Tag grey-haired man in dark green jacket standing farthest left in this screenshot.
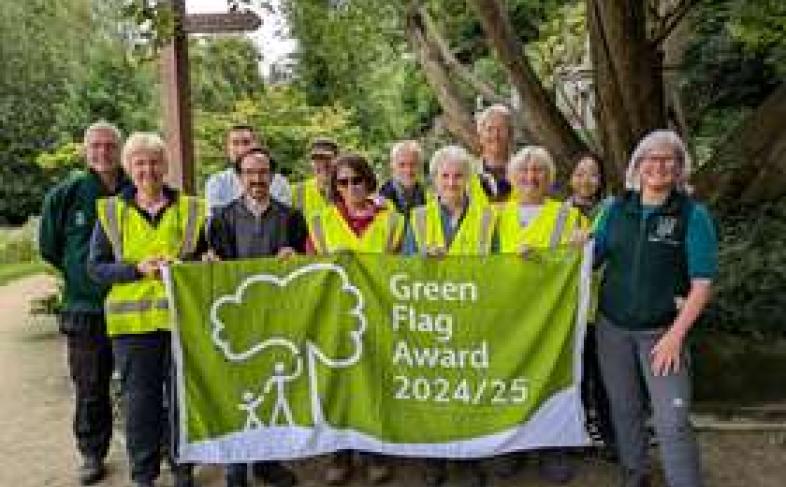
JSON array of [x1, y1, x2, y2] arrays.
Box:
[[39, 121, 125, 485]]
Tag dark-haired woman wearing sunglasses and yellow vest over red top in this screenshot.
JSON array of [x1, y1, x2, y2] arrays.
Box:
[[306, 154, 404, 485]]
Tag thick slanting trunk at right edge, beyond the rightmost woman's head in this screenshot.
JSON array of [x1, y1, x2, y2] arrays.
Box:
[[693, 83, 786, 204]]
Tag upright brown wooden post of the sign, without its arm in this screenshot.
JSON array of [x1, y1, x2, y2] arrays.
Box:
[[161, 0, 196, 194]]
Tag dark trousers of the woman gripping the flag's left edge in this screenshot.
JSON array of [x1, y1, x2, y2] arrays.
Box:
[[112, 331, 176, 482]]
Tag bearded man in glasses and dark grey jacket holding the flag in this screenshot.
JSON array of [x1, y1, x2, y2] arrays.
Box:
[[208, 147, 307, 487]]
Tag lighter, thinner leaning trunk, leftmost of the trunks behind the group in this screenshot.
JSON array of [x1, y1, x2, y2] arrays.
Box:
[[407, 8, 480, 153]]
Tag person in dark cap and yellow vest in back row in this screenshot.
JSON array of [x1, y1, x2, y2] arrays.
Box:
[[292, 138, 338, 219]]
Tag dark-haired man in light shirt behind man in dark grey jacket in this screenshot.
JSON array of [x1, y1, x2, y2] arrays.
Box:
[[205, 125, 292, 215]]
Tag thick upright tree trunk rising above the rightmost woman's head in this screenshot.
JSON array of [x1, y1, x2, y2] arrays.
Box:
[[587, 0, 667, 187]]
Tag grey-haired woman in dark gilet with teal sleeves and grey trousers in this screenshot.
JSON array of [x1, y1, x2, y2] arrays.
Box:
[[595, 130, 718, 487]]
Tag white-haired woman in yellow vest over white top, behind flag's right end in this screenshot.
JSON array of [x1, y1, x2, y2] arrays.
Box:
[[498, 146, 589, 484]]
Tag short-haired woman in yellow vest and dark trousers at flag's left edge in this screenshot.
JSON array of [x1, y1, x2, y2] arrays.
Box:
[[88, 132, 206, 487]]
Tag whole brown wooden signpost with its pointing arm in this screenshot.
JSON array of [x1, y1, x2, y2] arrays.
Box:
[[161, 0, 262, 194]]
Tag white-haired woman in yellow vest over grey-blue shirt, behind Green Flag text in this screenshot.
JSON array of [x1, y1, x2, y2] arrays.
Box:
[[403, 146, 497, 487]]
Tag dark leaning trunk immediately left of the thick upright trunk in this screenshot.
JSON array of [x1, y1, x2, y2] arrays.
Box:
[[468, 0, 586, 172]]
